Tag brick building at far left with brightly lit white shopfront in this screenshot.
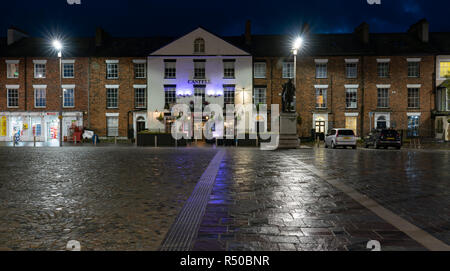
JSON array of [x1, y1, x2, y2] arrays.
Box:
[[0, 28, 89, 142]]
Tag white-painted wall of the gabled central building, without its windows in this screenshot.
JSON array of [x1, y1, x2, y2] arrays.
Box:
[[147, 28, 253, 133]]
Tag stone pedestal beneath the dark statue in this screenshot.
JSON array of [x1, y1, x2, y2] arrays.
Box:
[[278, 113, 300, 149]]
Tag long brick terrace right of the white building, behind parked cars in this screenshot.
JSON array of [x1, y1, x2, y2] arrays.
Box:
[[248, 21, 436, 140]]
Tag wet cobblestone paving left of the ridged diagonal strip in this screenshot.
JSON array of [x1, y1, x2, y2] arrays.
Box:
[[0, 147, 216, 250]]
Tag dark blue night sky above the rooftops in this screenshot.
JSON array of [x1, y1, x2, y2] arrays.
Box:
[[0, 0, 450, 37]]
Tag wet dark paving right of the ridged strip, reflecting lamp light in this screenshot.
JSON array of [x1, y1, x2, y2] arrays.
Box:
[[193, 149, 450, 251]]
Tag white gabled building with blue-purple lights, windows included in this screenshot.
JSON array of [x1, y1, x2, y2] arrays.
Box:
[[147, 28, 253, 138]]
